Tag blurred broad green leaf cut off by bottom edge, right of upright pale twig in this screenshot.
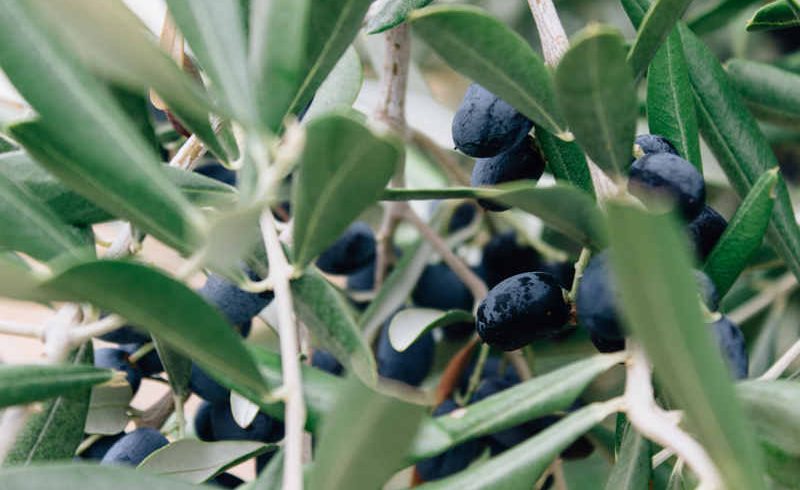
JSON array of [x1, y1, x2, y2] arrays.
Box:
[[308, 378, 425, 490]]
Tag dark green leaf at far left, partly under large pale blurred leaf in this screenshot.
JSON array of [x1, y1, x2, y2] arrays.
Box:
[[7, 123, 202, 252]]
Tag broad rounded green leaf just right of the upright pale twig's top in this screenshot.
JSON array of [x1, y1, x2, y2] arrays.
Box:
[[292, 114, 403, 267]]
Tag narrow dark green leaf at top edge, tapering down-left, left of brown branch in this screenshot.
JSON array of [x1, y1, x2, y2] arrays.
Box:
[[289, 0, 372, 114]]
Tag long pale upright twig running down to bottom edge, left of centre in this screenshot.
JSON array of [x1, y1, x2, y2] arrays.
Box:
[[260, 209, 306, 490]]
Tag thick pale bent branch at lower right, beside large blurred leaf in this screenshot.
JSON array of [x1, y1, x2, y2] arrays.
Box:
[[625, 341, 723, 488]]
